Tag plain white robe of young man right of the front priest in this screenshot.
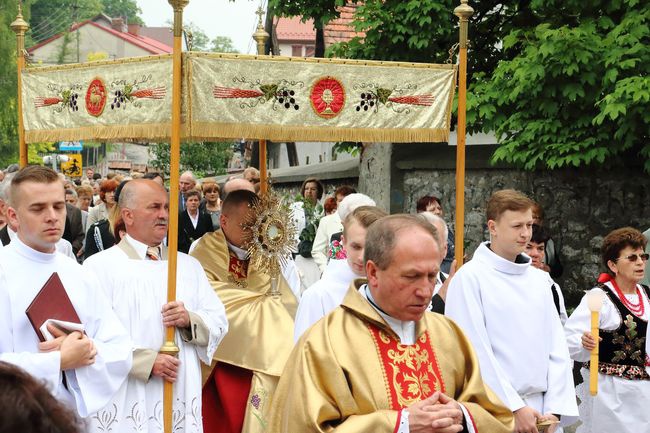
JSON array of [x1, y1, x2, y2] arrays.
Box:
[[445, 242, 578, 425]]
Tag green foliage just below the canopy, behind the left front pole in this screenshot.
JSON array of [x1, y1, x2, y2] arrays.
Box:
[[149, 141, 232, 177]]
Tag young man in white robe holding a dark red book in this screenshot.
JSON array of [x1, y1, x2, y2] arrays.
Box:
[[0, 166, 131, 418]]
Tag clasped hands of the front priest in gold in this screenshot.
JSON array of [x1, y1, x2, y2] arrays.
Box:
[[407, 391, 463, 433]]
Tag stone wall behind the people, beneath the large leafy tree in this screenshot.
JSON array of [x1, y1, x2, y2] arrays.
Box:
[[402, 161, 650, 307]]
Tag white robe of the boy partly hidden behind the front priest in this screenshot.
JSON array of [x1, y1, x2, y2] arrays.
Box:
[[293, 260, 362, 341]]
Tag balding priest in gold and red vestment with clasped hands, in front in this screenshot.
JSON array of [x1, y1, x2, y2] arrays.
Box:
[[268, 215, 514, 433]]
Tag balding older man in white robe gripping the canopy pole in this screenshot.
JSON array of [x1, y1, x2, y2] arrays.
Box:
[[84, 179, 228, 433]]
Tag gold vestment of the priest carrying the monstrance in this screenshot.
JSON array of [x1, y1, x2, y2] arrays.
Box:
[[192, 230, 297, 433]]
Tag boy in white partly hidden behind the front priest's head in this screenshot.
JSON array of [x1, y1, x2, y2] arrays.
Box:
[[293, 206, 387, 341]]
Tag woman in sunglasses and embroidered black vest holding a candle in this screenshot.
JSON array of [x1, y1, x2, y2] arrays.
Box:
[[565, 227, 650, 433]]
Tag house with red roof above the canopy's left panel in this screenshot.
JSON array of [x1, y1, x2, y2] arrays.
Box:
[[27, 14, 172, 65]]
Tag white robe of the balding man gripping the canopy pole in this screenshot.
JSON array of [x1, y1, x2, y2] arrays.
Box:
[[84, 235, 228, 433]]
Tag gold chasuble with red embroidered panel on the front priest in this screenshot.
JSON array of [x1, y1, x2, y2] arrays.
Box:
[[269, 282, 514, 433]]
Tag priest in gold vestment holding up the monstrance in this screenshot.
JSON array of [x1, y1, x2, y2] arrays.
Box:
[[191, 190, 297, 433]]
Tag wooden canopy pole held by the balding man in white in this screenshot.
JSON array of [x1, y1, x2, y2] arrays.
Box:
[[160, 0, 189, 433]]
